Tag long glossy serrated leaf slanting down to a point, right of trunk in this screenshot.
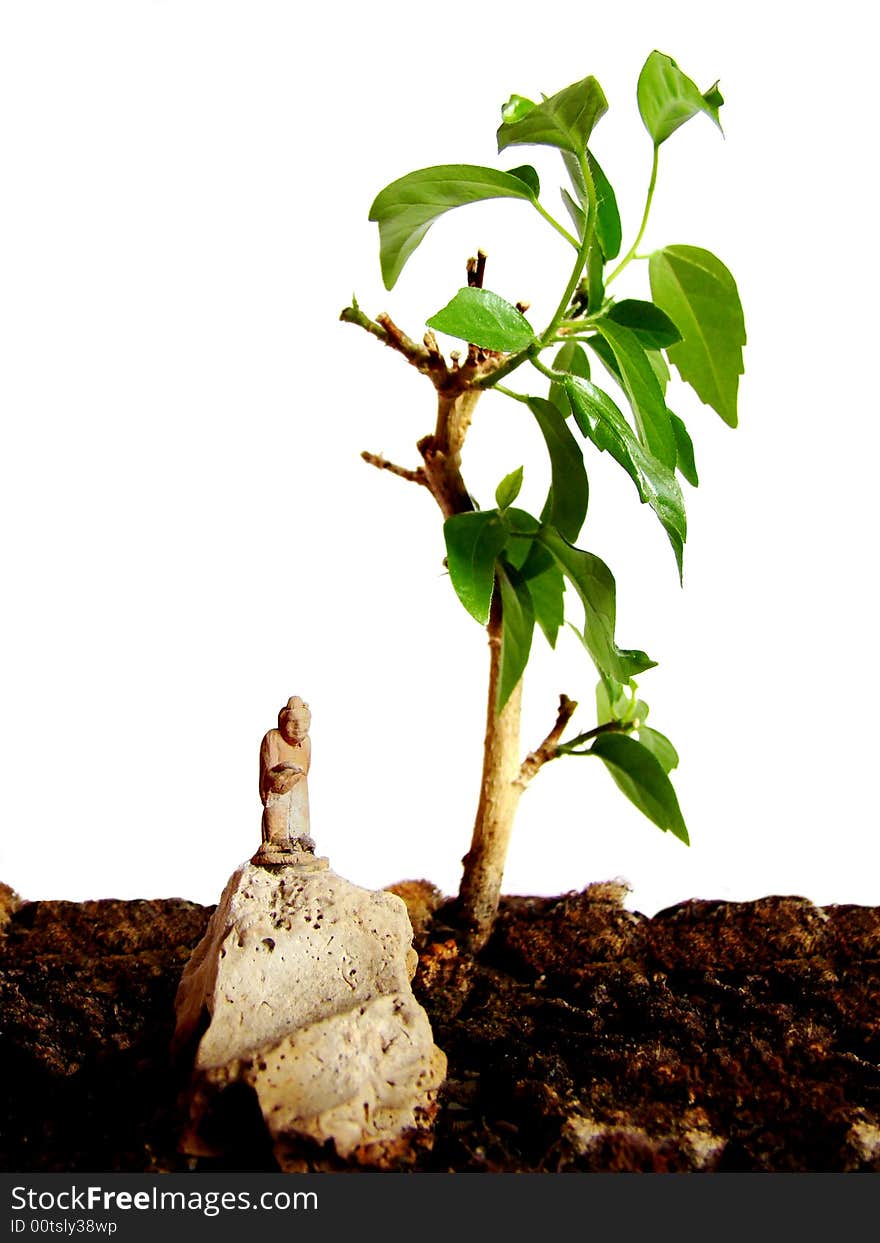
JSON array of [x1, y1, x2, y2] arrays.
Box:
[[563, 375, 687, 577]]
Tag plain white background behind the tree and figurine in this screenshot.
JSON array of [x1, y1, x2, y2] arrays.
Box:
[[0, 0, 880, 914]]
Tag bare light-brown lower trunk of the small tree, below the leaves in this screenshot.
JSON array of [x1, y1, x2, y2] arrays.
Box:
[[459, 587, 522, 952]]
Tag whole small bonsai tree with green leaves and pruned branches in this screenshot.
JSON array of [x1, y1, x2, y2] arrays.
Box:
[[342, 51, 746, 951]]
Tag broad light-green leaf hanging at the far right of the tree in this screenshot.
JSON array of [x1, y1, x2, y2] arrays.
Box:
[[649, 246, 746, 428]]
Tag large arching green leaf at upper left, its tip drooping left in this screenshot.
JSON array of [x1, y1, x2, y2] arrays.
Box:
[[369, 164, 537, 290]]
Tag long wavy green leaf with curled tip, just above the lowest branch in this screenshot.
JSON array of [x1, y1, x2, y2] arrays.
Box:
[[538, 526, 656, 682]]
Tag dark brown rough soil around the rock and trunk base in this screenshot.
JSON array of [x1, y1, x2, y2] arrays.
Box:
[[0, 883, 880, 1172]]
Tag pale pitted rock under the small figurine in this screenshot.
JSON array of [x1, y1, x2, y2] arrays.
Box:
[[174, 856, 446, 1168]]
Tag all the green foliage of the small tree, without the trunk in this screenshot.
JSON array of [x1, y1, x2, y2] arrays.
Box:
[[357, 51, 746, 842]]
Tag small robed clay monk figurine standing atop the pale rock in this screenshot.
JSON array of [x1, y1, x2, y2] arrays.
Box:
[[254, 695, 314, 864]]
